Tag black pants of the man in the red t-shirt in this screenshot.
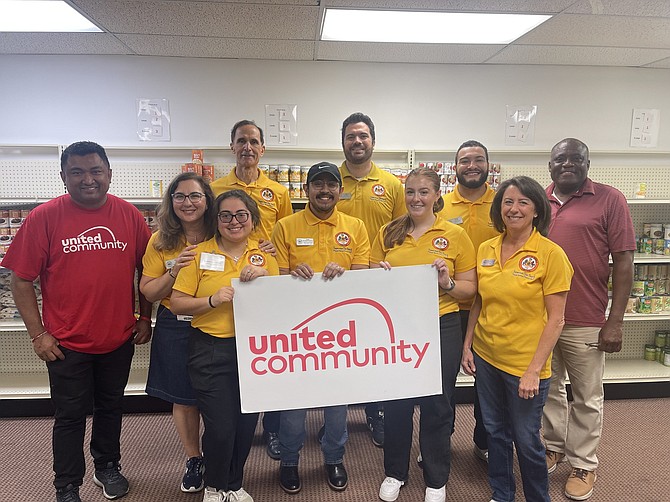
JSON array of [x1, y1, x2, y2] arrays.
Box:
[[47, 340, 135, 489]]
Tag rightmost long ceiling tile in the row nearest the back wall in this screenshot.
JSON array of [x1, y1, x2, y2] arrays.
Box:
[[487, 45, 670, 66]]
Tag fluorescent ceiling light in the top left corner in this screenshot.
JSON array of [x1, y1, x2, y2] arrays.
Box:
[[0, 0, 102, 32]]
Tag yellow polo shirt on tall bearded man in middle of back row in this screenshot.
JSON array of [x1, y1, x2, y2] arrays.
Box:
[[337, 162, 407, 242]]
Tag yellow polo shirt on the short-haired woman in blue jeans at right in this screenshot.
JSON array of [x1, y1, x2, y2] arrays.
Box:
[[472, 230, 573, 378]]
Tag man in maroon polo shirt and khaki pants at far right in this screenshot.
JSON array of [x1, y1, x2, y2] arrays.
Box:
[[543, 138, 636, 500]]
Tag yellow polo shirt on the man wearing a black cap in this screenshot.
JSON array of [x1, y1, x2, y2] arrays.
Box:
[[272, 204, 370, 272]]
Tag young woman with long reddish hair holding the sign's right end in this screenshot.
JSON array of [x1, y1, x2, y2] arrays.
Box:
[[370, 168, 476, 502]]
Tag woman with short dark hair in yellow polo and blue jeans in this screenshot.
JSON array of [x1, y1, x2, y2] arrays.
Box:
[[462, 176, 573, 502]]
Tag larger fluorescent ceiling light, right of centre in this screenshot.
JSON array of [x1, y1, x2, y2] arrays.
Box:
[[321, 9, 551, 44]]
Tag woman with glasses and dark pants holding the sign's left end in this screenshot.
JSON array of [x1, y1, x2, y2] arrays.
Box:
[[170, 190, 279, 502]]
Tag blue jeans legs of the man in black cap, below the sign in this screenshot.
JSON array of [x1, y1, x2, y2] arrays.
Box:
[[279, 405, 349, 467]]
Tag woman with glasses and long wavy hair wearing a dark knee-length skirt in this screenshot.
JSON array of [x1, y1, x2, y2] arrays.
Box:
[[140, 173, 216, 492]]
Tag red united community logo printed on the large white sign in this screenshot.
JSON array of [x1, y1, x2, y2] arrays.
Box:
[[248, 298, 431, 376]]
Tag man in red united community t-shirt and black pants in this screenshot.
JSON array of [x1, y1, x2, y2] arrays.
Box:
[[2, 142, 151, 502]]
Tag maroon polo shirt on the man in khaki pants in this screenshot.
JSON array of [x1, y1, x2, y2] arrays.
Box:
[[547, 178, 636, 326]]
